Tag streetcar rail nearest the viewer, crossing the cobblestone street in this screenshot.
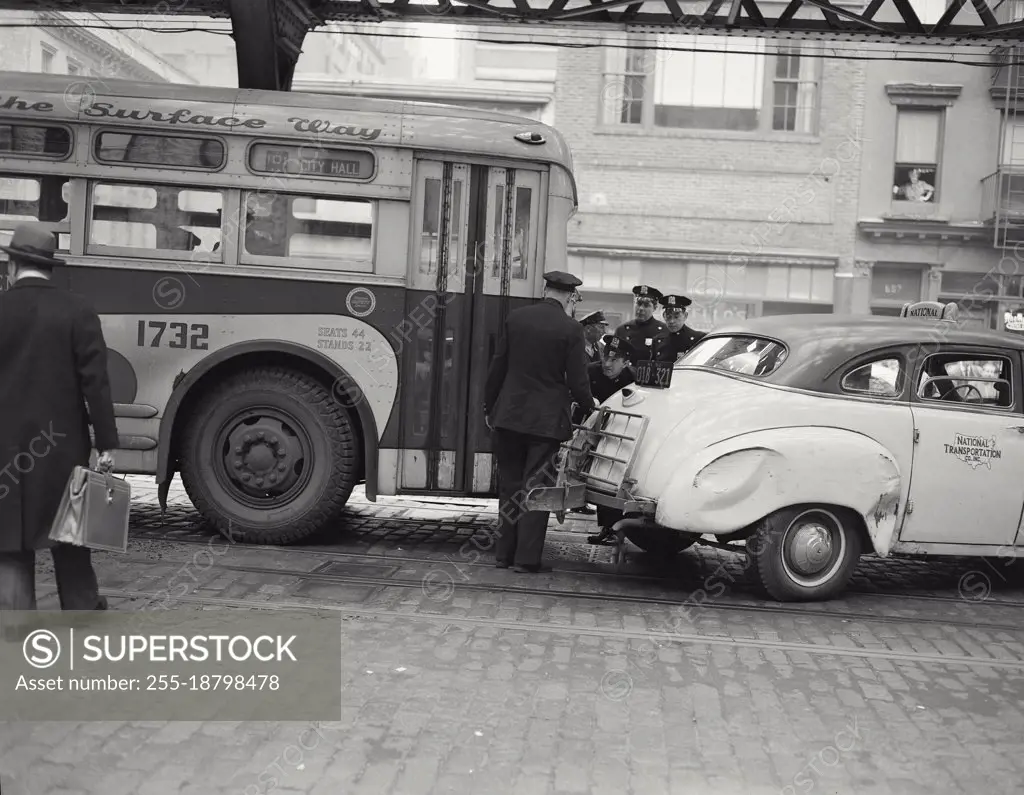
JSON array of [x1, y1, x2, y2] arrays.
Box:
[[86, 588, 1024, 671]]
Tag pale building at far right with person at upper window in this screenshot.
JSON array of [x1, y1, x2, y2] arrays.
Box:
[[851, 2, 1024, 332]]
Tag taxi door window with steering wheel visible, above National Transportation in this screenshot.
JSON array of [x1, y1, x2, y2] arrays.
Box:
[[918, 353, 1014, 409]]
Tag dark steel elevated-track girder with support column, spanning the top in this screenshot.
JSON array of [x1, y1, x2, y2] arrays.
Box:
[[0, 0, 1024, 90]]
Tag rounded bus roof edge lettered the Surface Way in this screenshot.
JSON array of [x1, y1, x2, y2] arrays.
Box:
[[0, 72, 575, 194]]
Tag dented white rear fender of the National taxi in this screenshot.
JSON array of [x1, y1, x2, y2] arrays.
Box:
[[655, 426, 903, 556]]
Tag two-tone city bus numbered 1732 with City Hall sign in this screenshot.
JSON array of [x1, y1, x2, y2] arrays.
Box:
[[0, 73, 578, 544]]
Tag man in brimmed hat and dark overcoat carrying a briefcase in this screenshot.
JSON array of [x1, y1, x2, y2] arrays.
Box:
[[0, 223, 118, 611]]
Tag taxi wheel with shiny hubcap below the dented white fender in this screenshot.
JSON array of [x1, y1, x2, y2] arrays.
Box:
[[748, 505, 861, 601]]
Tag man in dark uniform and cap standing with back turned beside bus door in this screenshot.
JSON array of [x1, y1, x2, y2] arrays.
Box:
[[483, 270, 594, 573]]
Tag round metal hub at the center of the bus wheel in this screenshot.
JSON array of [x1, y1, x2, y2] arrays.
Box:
[[217, 409, 312, 507]]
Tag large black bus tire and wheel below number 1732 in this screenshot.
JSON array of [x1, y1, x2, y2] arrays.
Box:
[[181, 367, 359, 544]]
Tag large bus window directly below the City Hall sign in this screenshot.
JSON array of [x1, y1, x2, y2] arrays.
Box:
[[245, 193, 374, 270]]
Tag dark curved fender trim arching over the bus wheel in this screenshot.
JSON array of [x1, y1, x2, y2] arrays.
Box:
[[157, 340, 379, 511]]
